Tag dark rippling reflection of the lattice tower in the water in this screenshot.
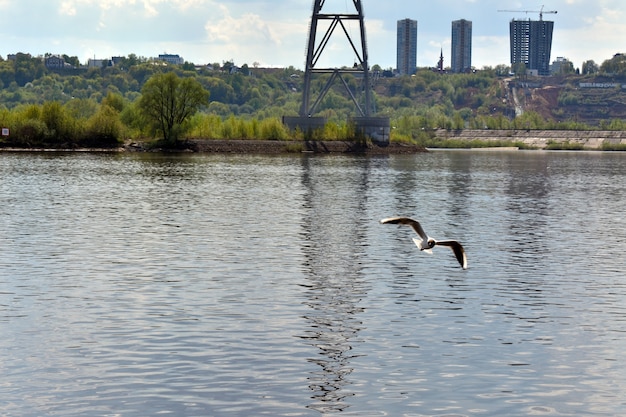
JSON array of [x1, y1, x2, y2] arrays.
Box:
[[302, 157, 368, 413]]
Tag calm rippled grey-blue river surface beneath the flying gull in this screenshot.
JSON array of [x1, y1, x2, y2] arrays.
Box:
[[0, 151, 626, 416]]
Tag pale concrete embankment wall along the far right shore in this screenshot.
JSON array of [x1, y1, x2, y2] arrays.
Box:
[[436, 129, 626, 149]]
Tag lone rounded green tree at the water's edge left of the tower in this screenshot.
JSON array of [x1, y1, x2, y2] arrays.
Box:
[[139, 72, 209, 145]]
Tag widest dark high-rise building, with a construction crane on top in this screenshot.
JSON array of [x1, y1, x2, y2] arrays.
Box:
[[509, 20, 554, 75]]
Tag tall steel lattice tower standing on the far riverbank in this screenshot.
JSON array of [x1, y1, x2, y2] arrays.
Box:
[[300, 0, 371, 117]]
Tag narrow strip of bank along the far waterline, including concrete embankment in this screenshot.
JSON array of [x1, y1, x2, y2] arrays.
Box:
[[0, 129, 626, 155]]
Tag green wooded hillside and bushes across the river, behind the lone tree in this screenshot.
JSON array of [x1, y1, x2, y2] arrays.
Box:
[[0, 54, 626, 146]]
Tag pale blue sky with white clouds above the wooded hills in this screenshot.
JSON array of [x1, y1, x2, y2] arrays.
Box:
[[0, 0, 626, 69]]
